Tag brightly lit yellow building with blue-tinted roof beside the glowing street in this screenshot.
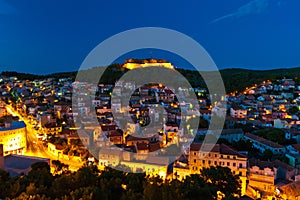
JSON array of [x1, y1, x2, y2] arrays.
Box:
[[0, 121, 26, 156]]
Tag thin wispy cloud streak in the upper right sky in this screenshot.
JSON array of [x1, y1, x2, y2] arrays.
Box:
[[210, 0, 280, 24]]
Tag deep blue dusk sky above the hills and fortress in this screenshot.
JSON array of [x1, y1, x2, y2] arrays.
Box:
[[0, 0, 300, 74]]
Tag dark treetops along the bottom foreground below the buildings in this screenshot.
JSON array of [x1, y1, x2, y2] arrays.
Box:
[[0, 161, 240, 200]]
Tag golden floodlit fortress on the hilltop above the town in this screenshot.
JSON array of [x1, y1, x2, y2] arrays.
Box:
[[123, 58, 174, 70]]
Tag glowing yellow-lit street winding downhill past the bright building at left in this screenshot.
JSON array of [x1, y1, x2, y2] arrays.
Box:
[[6, 105, 82, 171]]
